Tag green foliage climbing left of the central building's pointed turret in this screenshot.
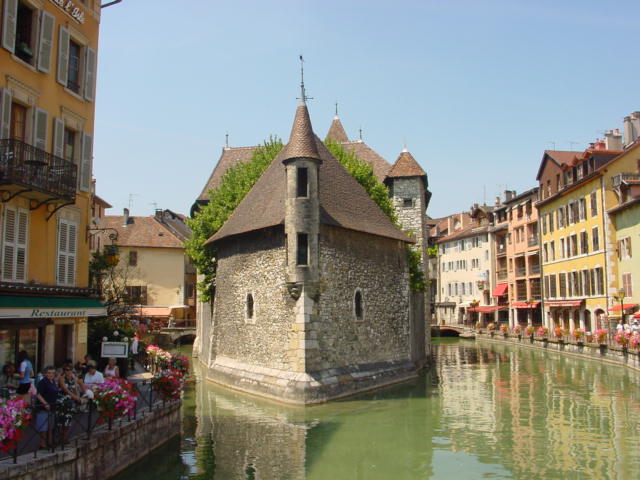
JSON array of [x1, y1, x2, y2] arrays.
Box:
[[185, 137, 283, 302]]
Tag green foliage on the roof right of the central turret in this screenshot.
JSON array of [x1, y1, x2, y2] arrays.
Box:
[[325, 140, 398, 225]]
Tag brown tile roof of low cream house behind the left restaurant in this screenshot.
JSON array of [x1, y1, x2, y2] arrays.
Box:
[[101, 215, 184, 248]]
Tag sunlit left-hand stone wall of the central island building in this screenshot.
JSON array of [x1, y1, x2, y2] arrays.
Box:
[[212, 228, 296, 370]]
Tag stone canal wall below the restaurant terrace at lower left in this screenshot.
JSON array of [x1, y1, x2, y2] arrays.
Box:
[[0, 400, 181, 480]]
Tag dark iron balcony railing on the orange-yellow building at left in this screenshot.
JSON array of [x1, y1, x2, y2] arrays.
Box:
[[0, 139, 78, 200]]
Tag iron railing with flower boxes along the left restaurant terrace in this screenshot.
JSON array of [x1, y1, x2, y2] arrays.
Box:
[[0, 380, 172, 463]]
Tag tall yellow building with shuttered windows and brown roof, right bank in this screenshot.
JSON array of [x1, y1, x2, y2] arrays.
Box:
[[536, 147, 620, 331]]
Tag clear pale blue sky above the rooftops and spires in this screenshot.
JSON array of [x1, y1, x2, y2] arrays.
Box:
[[94, 0, 640, 218]]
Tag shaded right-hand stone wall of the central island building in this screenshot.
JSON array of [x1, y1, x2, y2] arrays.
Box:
[[307, 225, 410, 372]]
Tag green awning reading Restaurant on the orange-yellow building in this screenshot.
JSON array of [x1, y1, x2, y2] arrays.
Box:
[[0, 295, 107, 319]]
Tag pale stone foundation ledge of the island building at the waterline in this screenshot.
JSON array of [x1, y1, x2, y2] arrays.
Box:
[[202, 357, 418, 405]]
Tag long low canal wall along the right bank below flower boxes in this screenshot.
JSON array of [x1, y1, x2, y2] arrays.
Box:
[[476, 332, 640, 371]]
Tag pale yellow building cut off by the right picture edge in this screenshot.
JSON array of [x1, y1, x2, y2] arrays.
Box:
[[604, 140, 640, 322]]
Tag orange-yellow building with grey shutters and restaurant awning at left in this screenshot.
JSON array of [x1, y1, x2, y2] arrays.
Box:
[[0, 0, 104, 368]]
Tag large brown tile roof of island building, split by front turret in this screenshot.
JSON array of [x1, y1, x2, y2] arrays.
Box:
[[208, 137, 413, 243]]
